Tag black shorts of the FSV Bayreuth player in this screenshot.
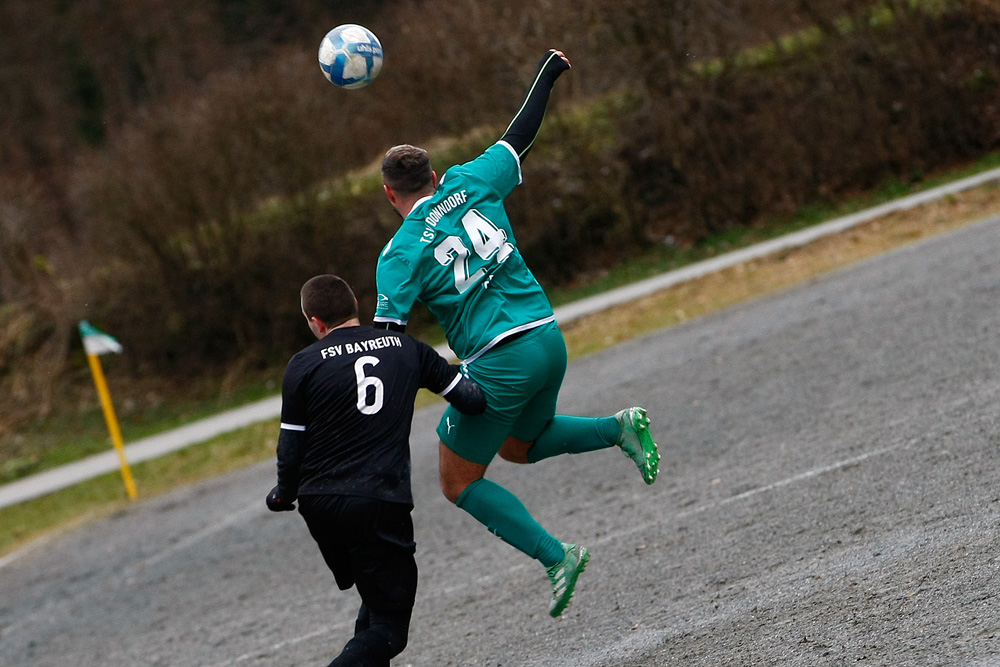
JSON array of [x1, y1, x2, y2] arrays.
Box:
[[299, 495, 417, 612]]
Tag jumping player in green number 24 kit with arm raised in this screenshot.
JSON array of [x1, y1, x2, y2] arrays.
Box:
[[374, 50, 660, 616]]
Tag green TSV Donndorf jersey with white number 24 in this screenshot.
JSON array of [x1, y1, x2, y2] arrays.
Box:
[[374, 141, 555, 362]]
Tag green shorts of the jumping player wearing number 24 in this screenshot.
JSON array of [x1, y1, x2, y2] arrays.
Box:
[[437, 322, 566, 465]]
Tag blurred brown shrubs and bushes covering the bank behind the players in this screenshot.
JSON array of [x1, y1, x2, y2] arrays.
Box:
[[0, 0, 1000, 428]]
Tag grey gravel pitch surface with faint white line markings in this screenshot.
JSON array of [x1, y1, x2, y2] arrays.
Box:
[[0, 213, 1000, 667]]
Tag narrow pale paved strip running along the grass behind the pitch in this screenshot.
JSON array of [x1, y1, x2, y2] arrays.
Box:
[[0, 164, 1000, 507]]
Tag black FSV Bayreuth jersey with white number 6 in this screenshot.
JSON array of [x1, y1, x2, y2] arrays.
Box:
[[279, 326, 463, 504]]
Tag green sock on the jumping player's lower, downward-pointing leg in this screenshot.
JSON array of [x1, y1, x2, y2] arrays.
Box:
[[455, 479, 565, 567]]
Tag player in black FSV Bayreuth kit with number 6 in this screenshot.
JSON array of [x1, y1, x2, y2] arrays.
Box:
[[267, 275, 486, 667]]
